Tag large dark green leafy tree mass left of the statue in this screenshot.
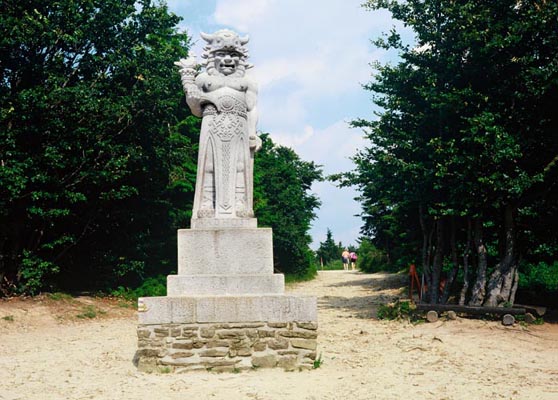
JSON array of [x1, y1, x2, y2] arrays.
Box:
[[0, 0, 195, 292]]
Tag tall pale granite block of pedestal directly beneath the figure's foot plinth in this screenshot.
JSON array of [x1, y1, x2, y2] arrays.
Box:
[[178, 228, 273, 275]]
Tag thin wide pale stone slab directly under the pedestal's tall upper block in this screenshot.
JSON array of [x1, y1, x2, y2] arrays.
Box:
[[167, 274, 285, 296]]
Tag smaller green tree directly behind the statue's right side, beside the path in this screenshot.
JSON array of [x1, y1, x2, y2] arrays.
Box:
[[254, 134, 322, 277]]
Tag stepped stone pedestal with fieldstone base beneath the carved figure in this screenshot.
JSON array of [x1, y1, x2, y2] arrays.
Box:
[[135, 218, 317, 371]]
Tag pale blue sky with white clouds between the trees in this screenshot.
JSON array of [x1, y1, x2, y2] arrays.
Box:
[[167, 0, 406, 249]]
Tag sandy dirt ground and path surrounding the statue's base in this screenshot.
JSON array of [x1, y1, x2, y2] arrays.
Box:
[[0, 271, 558, 400]]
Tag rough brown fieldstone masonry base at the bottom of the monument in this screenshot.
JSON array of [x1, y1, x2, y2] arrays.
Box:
[[135, 322, 318, 372]]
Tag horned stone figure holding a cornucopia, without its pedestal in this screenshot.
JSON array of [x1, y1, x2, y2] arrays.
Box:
[[175, 29, 261, 225]]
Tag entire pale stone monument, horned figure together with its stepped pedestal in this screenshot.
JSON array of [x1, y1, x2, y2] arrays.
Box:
[[134, 30, 318, 372]]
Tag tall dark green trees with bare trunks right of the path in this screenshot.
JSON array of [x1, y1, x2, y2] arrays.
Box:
[[343, 0, 558, 305]]
